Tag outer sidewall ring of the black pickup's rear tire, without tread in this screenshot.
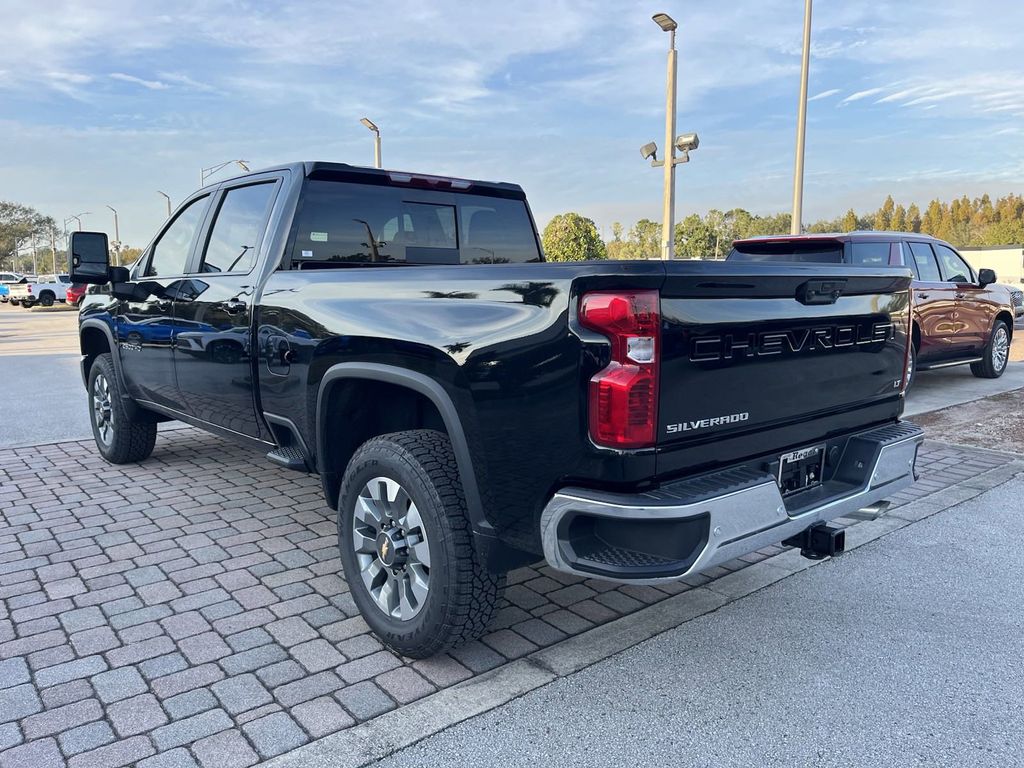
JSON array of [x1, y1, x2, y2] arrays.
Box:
[[338, 442, 455, 645]]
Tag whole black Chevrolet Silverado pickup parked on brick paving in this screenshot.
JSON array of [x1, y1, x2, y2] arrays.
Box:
[[69, 163, 922, 656]]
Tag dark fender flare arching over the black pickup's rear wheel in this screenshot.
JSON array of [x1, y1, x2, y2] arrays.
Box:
[[316, 362, 495, 537]]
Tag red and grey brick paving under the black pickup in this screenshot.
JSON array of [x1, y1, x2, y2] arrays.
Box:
[[0, 429, 1012, 768]]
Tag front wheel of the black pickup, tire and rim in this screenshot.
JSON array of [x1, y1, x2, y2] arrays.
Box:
[[89, 352, 157, 464]]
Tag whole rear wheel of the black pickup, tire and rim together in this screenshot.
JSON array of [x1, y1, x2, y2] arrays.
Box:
[[338, 429, 505, 658]]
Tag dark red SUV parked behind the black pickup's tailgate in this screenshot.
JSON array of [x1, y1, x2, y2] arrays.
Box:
[[726, 231, 1016, 388]]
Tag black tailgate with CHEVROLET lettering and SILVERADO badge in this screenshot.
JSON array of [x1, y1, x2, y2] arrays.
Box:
[[657, 263, 910, 474]]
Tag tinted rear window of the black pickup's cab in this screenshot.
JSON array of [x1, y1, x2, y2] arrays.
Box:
[[291, 179, 541, 269]]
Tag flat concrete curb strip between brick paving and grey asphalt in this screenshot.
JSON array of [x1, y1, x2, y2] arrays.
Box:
[[263, 460, 1024, 768]]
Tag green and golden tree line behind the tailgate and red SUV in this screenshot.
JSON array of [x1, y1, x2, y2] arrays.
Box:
[[543, 194, 1024, 261]]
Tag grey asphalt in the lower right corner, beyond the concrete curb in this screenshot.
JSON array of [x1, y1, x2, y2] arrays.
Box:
[[378, 479, 1024, 768]]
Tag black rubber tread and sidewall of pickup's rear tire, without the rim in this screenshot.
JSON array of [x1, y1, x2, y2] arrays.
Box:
[[338, 429, 505, 658]]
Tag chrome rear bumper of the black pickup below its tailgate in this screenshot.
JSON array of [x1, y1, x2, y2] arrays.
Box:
[[541, 422, 924, 584]]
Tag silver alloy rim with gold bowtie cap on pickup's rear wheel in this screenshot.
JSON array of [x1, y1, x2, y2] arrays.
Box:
[[352, 477, 430, 622]]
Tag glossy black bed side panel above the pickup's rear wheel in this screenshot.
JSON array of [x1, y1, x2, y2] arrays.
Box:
[[256, 262, 664, 551]]
